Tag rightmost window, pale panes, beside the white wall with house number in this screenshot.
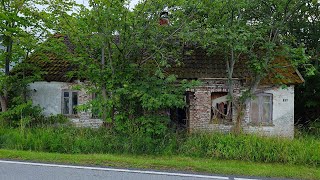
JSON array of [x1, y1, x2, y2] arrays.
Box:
[[250, 94, 272, 124]]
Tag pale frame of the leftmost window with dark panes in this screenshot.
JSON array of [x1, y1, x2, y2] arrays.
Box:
[[61, 89, 79, 116]]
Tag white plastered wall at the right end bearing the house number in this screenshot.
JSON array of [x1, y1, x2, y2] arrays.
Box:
[[244, 85, 294, 138]]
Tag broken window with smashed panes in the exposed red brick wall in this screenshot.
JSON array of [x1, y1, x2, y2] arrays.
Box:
[[211, 92, 232, 123]]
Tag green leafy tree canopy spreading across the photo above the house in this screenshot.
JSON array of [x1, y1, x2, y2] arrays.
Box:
[[0, 0, 319, 129]]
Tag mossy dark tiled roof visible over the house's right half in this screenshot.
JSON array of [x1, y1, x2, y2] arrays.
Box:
[[168, 48, 304, 84]]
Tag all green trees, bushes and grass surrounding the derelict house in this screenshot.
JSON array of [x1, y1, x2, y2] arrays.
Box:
[[0, 0, 320, 179]]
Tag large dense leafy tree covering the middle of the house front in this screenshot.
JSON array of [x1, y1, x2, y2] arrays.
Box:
[[43, 0, 196, 125]]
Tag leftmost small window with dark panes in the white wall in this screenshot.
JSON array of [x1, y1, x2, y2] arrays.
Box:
[[62, 90, 78, 115]]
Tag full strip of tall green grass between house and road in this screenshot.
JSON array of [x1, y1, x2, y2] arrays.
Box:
[[0, 127, 320, 166]]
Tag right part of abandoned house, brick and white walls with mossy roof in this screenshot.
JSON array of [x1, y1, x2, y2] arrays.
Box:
[[170, 49, 304, 138]]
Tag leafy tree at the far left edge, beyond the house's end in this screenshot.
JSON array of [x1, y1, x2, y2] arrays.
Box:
[[0, 0, 45, 112]]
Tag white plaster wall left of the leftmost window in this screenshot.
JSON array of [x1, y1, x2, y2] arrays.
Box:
[[29, 81, 67, 116]]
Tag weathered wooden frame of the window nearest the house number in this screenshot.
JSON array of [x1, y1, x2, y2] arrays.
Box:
[[250, 93, 273, 126]]
